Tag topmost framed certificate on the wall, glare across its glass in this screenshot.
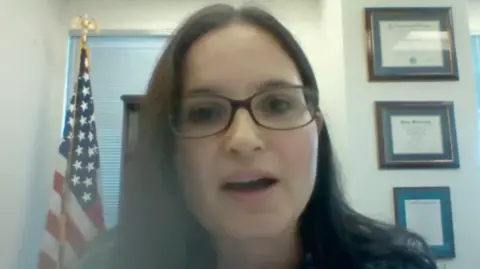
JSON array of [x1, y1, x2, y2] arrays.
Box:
[[365, 7, 459, 81]]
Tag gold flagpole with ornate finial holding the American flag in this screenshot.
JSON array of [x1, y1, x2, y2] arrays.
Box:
[[58, 14, 98, 269]]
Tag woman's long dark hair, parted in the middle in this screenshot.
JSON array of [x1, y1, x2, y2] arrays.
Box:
[[114, 5, 434, 269]]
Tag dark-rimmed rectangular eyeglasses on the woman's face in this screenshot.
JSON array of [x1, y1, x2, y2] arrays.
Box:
[[170, 86, 318, 138]]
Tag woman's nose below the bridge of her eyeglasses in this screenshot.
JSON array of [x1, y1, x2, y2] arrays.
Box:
[[225, 109, 265, 157]]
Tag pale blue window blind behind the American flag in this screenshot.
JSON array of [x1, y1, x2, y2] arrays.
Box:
[[66, 36, 167, 228]]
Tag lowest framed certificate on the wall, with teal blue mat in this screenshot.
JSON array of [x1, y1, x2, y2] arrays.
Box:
[[393, 186, 455, 259]]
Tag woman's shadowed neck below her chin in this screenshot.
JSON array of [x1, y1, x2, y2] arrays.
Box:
[[216, 227, 301, 269]]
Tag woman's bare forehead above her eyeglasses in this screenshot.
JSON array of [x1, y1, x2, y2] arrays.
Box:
[[184, 23, 301, 97]]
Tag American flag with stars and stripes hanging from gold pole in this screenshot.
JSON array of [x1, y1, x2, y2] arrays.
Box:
[[38, 44, 105, 269]]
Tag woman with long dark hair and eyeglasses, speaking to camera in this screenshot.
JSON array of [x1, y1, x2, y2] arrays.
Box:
[[81, 5, 435, 269]]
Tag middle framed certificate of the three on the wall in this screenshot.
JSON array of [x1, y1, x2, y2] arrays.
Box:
[[375, 102, 460, 169]]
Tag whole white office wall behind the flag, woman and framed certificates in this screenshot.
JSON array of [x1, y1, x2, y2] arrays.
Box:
[[0, 0, 480, 269]]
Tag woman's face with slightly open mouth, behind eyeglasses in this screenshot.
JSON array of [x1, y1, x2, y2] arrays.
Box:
[[176, 23, 318, 240]]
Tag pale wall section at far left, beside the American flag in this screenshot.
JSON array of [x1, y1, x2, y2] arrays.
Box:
[[0, 0, 67, 269]]
